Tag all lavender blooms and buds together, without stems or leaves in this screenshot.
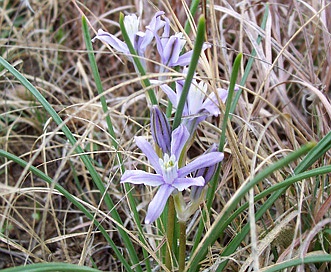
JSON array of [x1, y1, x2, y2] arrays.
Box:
[[92, 11, 228, 224]]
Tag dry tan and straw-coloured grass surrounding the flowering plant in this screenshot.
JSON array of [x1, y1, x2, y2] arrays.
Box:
[[0, 0, 331, 271]]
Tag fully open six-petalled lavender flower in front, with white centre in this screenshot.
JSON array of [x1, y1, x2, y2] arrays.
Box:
[[121, 125, 223, 224]]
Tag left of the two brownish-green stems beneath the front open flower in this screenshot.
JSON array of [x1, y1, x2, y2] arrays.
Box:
[[165, 196, 176, 271]]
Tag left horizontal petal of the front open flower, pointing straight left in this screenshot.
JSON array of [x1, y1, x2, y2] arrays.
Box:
[[121, 170, 164, 186]]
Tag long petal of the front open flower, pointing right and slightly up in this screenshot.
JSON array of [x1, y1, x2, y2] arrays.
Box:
[[178, 152, 224, 177]]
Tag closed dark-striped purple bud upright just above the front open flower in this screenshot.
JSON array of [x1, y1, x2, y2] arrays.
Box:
[[151, 105, 171, 154]]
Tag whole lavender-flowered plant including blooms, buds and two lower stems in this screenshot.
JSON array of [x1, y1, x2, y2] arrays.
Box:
[[92, 11, 236, 270]]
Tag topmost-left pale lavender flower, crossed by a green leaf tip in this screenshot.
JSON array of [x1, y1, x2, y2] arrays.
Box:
[[92, 11, 165, 67]]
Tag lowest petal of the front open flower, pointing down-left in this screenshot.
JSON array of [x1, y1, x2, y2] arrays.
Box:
[[145, 184, 175, 224]]
